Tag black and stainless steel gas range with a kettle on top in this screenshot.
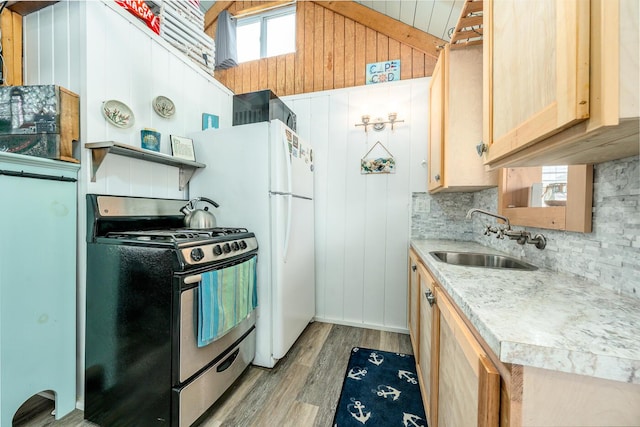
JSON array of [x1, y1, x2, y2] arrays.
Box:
[[85, 194, 258, 427]]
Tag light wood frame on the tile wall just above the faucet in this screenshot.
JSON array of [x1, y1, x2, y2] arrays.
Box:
[[498, 165, 593, 233]]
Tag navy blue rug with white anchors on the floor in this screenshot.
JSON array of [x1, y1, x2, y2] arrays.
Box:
[[333, 347, 427, 427]]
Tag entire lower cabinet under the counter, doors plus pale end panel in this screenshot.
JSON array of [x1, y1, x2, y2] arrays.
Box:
[[409, 249, 640, 427]]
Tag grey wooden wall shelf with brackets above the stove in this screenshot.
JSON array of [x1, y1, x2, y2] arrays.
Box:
[[84, 141, 207, 190]]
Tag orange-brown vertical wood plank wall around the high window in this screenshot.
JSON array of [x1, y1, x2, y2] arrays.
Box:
[[205, 1, 436, 96]]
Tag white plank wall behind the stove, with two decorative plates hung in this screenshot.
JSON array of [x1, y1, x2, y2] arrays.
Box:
[[24, 1, 233, 408]]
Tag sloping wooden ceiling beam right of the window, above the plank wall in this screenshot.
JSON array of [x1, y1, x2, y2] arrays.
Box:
[[314, 1, 447, 58]]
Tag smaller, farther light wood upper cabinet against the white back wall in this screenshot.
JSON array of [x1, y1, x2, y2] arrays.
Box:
[[428, 45, 498, 192]]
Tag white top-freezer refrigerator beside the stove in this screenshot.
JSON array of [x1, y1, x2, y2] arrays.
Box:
[[189, 120, 315, 368]]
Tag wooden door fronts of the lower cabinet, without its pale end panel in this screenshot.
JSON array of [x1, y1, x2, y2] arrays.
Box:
[[409, 250, 500, 427]]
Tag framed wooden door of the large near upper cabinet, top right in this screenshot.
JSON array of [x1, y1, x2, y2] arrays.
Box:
[[484, 0, 589, 158]]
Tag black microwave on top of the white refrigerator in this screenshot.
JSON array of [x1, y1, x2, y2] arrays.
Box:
[[233, 90, 297, 132]]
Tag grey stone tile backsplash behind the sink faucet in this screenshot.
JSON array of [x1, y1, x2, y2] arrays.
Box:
[[411, 156, 640, 298]]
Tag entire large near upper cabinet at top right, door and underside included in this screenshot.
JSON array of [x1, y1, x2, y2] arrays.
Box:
[[483, 0, 640, 168]]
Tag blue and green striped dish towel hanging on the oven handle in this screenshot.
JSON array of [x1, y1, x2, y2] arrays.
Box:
[[198, 257, 258, 347]]
